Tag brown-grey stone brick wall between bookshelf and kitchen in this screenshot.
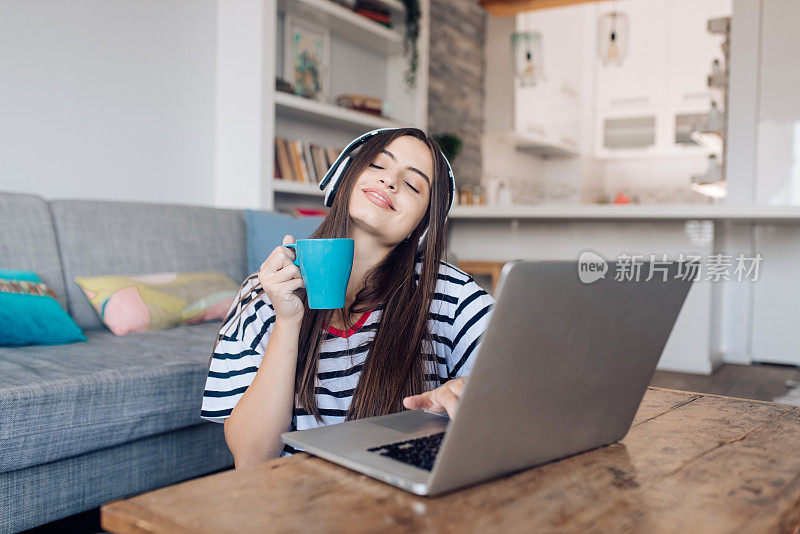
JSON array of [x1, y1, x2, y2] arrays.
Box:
[[428, 0, 488, 188]]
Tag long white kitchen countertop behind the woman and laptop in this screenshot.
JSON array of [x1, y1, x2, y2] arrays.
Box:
[[448, 204, 800, 222]]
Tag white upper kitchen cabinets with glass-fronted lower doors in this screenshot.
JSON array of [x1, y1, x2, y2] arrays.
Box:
[[593, 0, 732, 159]]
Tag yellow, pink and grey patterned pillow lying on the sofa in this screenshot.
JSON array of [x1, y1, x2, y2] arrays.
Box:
[[75, 272, 239, 336]]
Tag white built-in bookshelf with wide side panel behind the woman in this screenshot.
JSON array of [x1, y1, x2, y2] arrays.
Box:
[[209, 0, 430, 210]]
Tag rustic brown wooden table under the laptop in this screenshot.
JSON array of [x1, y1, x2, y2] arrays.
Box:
[[101, 388, 800, 534]]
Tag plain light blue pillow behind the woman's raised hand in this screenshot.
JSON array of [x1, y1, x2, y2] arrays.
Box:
[[244, 210, 325, 273]]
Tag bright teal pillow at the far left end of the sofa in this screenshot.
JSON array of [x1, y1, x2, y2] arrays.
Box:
[[0, 269, 86, 347]]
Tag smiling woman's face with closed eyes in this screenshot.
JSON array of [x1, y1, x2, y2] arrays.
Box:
[[350, 135, 433, 245]]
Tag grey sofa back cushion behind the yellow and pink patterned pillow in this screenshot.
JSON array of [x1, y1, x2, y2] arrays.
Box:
[[50, 200, 247, 330]]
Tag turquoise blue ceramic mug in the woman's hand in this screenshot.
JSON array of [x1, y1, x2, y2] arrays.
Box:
[[283, 238, 355, 310]]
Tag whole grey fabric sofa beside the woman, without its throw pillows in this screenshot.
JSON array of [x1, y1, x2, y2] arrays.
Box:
[[0, 193, 253, 534]]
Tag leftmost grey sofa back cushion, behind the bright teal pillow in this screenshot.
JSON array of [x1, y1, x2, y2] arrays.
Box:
[[0, 193, 69, 311]]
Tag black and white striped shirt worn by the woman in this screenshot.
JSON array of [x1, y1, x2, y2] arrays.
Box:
[[200, 261, 495, 455]]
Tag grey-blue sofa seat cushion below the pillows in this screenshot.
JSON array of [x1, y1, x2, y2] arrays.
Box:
[[0, 321, 222, 473]]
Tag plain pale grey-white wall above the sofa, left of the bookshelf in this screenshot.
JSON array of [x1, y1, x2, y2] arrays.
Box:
[[0, 0, 216, 205]]
